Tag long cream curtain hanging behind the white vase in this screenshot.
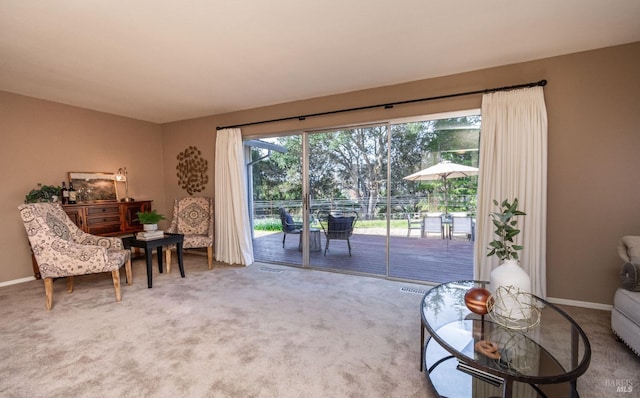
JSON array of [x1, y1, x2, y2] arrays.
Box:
[[474, 87, 547, 298]]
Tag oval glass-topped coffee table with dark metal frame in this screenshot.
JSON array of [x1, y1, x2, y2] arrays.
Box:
[[420, 281, 591, 398]]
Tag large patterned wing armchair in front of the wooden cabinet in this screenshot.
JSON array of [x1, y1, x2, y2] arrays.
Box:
[[18, 203, 132, 310]]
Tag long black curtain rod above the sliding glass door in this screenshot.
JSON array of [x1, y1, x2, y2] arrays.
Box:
[[216, 80, 547, 130]]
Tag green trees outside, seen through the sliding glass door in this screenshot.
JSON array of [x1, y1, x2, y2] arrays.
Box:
[[252, 116, 480, 219]]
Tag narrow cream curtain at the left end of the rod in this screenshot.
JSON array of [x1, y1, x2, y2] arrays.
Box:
[[215, 129, 253, 265]]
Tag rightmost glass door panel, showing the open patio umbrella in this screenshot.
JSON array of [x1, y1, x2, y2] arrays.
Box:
[[389, 116, 480, 283]]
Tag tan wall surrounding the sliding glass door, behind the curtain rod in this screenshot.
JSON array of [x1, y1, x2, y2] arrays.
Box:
[[163, 43, 640, 304]]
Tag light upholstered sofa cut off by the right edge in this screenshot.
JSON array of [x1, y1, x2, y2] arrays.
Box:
[[611, 236, 640, 356]]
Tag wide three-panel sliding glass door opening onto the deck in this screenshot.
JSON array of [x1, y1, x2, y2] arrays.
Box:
[[250, 111, 480, 282]]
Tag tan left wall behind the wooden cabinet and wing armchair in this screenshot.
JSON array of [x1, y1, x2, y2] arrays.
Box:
[[0, 92, 166, 282]]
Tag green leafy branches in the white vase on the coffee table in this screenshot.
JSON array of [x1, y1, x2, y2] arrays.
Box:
[[487, 198, 527, 261]]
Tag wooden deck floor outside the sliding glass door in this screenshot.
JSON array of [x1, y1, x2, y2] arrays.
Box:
[[253, 232, 473, 283]]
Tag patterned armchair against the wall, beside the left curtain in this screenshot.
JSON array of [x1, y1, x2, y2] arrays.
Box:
[[166, 196, 213, 272]]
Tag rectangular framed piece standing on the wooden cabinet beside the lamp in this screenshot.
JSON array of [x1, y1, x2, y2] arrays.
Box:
[[69, 171, 118, 203]]
